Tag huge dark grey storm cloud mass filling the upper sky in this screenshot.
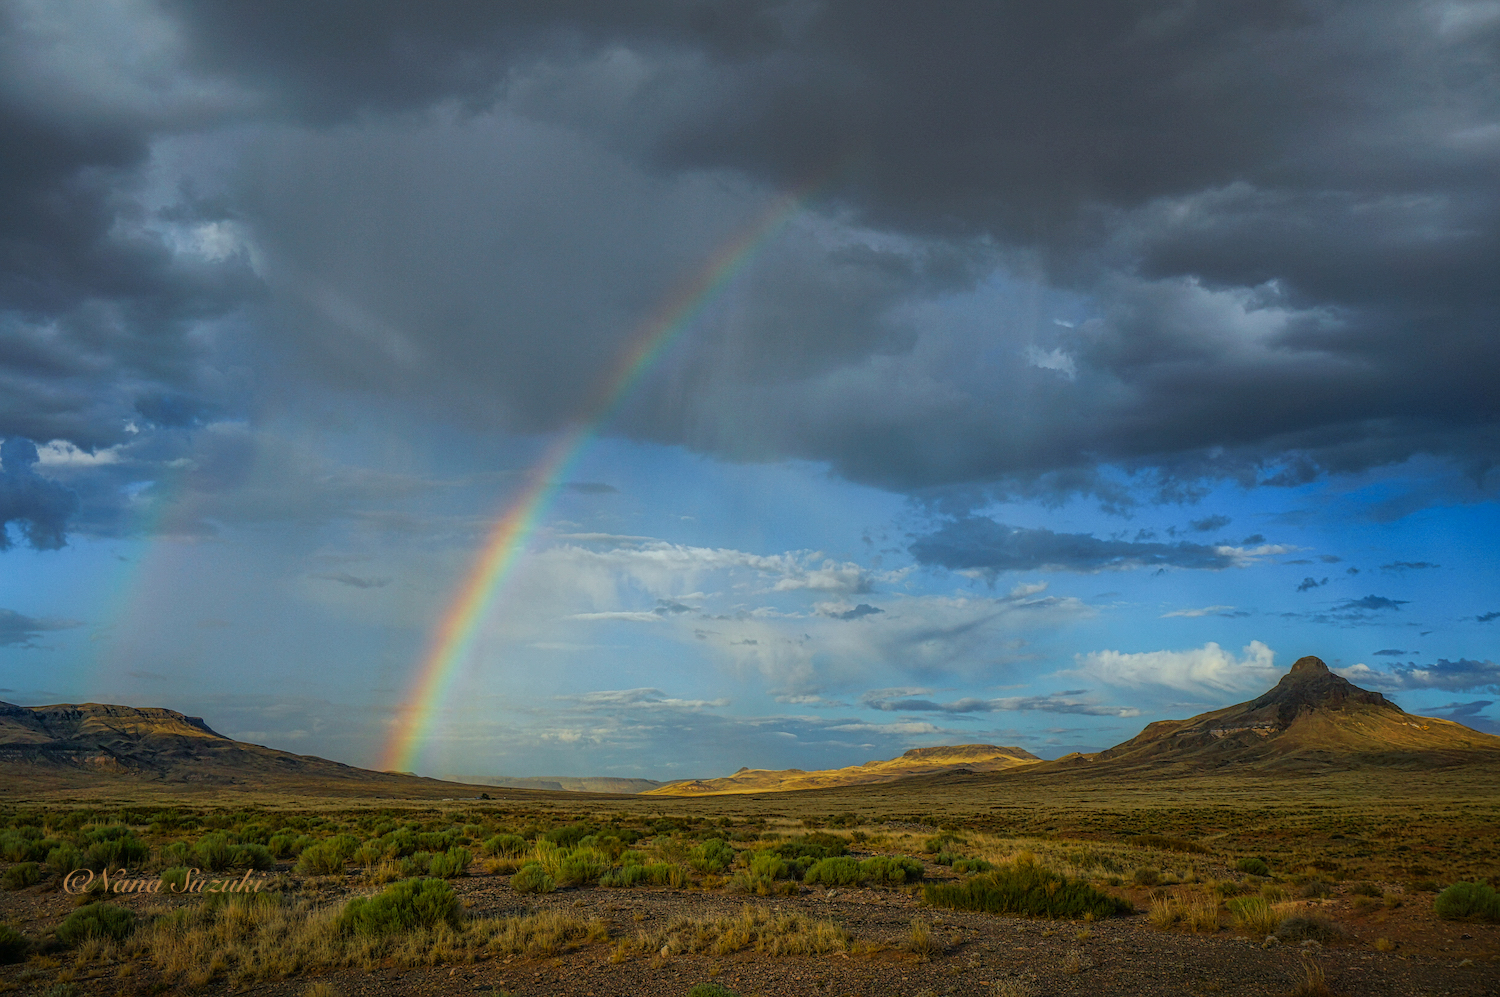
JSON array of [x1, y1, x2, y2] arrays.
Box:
[[0, 0, 1500, 533]]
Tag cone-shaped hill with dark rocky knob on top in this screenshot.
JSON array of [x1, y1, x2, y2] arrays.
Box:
[[1080, 657, 1500, 772]]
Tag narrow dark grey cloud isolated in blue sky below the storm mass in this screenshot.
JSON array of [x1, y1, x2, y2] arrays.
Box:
[[911, 516, 1236, 574]]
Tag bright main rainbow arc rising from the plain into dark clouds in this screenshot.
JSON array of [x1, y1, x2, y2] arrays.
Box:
[[381, 184, 813, 771]]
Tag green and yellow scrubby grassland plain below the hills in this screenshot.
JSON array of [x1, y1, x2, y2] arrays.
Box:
[[0, 769, 1500, 994]]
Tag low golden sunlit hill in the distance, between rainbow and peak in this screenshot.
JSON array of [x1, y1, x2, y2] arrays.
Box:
[[644, 744, 1041, 796]]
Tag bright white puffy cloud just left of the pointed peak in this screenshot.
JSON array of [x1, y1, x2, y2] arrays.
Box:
[[1061, 640, 1280, 693]]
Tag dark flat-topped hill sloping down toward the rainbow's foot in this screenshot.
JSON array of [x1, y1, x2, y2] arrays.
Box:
[[0, 703, 492, 796]]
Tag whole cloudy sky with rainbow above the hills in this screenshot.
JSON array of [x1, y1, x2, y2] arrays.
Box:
[[0, 0, 1500, 780]]
